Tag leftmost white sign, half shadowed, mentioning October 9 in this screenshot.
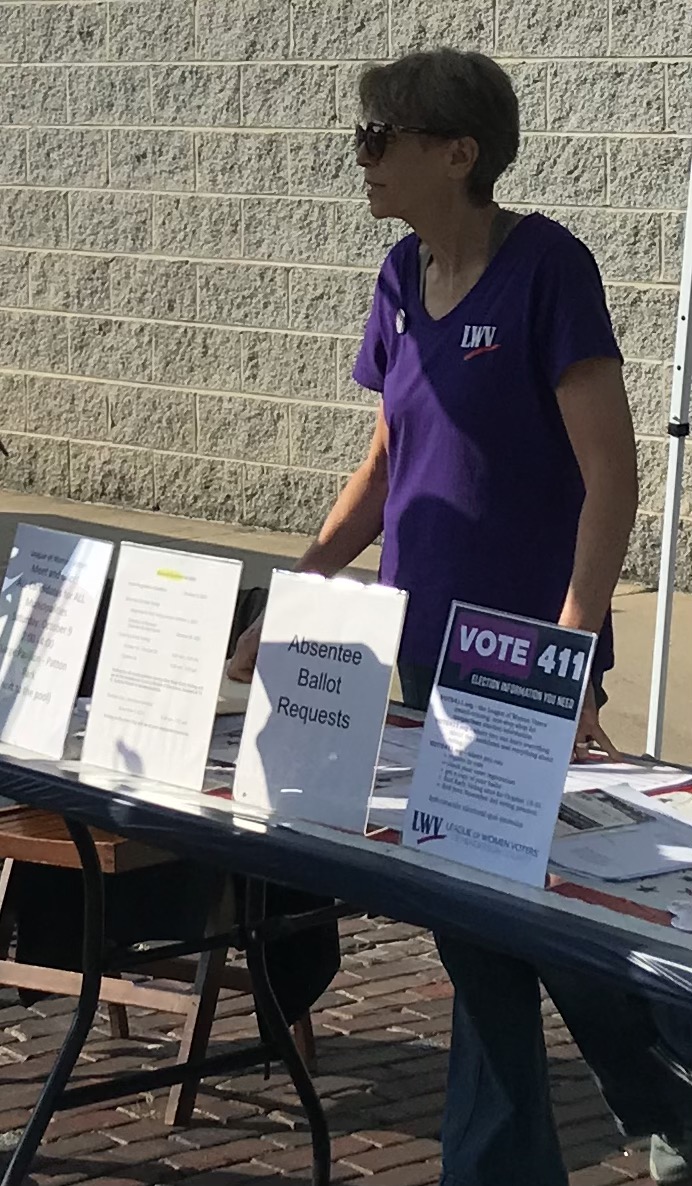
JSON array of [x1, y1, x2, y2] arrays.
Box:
[[0, 523, 113, 758]]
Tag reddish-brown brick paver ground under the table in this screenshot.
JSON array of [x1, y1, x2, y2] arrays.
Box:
[[0, 919, 650, 1186]]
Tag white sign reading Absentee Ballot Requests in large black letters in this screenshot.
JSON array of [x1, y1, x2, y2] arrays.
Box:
[[234, 572, 407, 833]]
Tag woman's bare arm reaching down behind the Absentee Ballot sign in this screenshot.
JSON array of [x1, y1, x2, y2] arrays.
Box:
[[228, 404, 387, 682]]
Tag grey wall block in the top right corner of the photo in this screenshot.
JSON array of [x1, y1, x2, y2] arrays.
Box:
[[610, 0, 692, 58]]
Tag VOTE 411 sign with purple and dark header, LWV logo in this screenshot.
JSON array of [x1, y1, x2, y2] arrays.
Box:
[[404, 602, 596, 886]]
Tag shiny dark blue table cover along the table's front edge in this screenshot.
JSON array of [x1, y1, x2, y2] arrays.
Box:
[[0, 754, 692, 1012]]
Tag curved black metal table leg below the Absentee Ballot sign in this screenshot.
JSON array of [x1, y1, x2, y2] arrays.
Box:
[[246, 879, 331, 1186]]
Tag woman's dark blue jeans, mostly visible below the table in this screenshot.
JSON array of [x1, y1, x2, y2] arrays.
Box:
[[400, 667, 692, 1186]]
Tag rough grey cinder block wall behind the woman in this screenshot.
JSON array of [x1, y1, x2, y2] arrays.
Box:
[[0, 0, 692, 586]]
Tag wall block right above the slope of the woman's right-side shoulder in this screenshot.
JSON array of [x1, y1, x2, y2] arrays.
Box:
[[544, 208, 661, 282]]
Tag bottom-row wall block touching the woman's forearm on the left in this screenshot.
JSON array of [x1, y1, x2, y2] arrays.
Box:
[[243, 465, 337, 535]]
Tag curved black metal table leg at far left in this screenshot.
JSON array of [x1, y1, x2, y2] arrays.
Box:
[[2, 820, 103, 1186]]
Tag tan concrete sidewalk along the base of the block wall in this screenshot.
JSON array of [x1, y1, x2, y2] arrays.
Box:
[[0, 493, 692, 764]]
